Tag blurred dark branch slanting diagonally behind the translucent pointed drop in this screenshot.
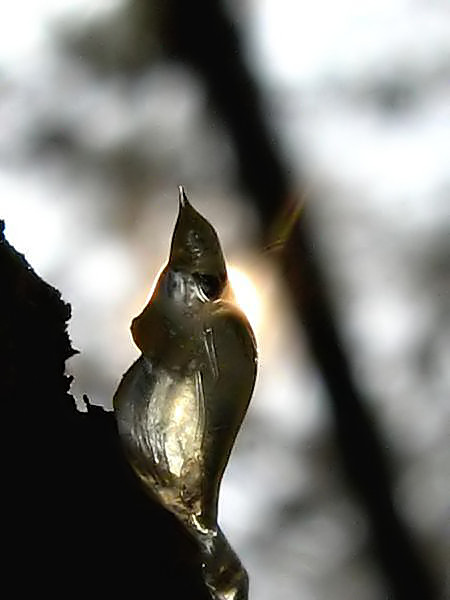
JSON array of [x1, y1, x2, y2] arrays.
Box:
[[163, 0, 436, 600]]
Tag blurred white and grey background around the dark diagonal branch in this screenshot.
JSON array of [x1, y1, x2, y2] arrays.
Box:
[[0, 0, 450, 600]]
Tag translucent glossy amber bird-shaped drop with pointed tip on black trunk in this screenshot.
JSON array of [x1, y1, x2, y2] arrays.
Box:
[[114, 187, 257, 600]]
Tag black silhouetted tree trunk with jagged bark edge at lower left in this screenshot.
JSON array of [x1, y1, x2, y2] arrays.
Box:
[[0, 223, 209, 600]]
